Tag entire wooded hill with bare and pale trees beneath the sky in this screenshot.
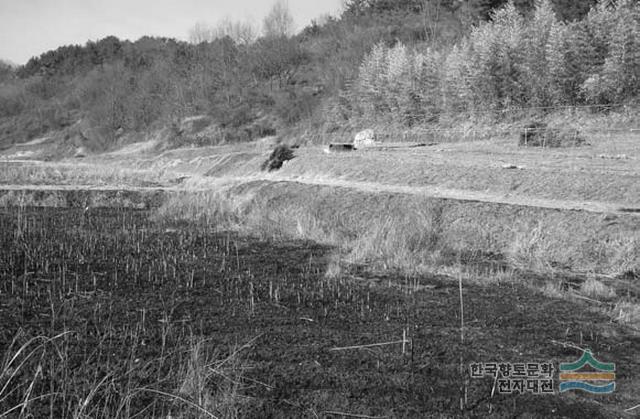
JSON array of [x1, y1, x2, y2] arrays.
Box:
[[5, 0, 640, 154]]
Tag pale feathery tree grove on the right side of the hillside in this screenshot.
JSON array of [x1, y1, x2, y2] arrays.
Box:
[[349, 0, 640, 125]]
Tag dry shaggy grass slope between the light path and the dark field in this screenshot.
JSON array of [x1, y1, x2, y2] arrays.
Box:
[[158, 181, 640, 275]]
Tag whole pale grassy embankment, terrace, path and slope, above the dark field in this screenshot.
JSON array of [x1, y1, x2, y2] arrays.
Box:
[[3, 111, 640, 324]]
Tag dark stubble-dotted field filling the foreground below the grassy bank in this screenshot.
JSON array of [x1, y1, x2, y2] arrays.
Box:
[[0, 209, 640, 418]]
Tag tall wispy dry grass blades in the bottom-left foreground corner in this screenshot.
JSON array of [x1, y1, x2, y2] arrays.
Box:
[[0, 331, 250, 419]]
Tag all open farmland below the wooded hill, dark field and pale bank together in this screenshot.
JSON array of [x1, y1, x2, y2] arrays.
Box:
[[0, 126, 640, 418]]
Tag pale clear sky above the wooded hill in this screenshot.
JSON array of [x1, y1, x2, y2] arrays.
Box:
[[0, 0, 342, 64]]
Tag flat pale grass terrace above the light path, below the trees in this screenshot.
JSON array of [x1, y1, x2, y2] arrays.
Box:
[[172, 115, 640, 206]]
